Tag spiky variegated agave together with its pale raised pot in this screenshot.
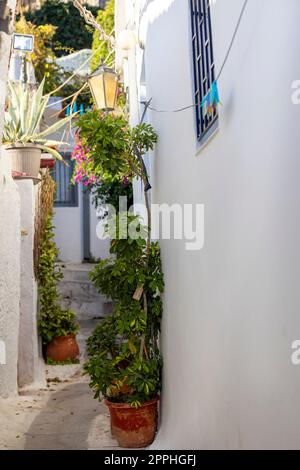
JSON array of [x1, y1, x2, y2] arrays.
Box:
[[3, 80, 73, 177]]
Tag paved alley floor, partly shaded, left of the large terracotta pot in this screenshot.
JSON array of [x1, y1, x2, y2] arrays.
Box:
[[0, 321, 117, 450]]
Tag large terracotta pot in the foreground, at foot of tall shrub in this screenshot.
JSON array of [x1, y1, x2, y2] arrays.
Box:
[[105, 398, 158, 449]]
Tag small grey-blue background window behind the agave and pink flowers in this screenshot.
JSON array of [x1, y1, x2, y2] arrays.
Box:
[[53, 153, 78, 207]]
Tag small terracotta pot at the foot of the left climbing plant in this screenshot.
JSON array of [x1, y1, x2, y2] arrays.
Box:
[[46, 333, 79, 362]]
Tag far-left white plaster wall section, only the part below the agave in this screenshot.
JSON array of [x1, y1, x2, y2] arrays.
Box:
[[0, 147, 21, 398]]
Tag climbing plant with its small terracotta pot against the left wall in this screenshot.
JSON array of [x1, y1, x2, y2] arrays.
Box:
[[38, 213, 79, 362]]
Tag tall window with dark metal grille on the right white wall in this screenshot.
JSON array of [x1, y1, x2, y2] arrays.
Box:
[[190, 0, 218, 142]]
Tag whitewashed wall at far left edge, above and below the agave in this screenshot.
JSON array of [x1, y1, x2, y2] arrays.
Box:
[[0, 0, 21, 397]]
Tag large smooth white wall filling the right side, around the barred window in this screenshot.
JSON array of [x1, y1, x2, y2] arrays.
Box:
[[127, 0, 300, 449]]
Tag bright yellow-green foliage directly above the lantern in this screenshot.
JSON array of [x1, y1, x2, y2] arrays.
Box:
[[91, 0, 115, 70]]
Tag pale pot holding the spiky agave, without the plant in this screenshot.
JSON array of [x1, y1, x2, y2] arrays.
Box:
[[6, 144, 42, 177]]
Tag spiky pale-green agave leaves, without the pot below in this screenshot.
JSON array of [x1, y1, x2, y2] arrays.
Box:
[[3, 79, 74, 160]]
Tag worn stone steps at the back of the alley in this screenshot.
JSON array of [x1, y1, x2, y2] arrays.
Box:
[[58, 263, 112, 320]]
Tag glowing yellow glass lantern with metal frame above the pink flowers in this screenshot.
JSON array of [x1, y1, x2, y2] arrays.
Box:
[[88, 61, 118, 111]]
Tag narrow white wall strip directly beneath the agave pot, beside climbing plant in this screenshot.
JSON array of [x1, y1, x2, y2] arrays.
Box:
[[17, 180, 45, 388]]
